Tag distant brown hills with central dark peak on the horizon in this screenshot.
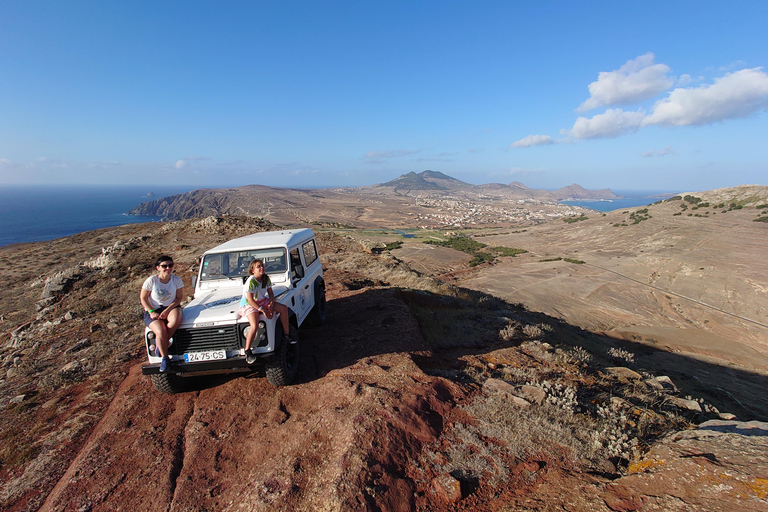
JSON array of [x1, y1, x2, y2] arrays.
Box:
[[130, 171, 618, 223]]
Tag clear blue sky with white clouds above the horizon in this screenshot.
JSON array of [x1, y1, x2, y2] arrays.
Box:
[[0, 0, 768, 191]]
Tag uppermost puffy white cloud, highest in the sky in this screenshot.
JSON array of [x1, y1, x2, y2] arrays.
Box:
[[576, 52, 674, 112]]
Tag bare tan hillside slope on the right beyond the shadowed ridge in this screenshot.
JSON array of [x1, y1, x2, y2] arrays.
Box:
[[390, 186, 768, 417]]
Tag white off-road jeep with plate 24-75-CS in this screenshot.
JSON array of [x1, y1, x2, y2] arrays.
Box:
[[142, 229, 326, 393]]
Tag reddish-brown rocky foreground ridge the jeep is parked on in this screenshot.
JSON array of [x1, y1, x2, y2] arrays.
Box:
[[0, 187, 768, 511]]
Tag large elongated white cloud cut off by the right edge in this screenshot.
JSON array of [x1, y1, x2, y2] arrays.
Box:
[[643, 68, 768, 126]]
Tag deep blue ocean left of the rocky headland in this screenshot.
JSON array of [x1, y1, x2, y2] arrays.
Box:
[[0, 185, 193, 247]]
